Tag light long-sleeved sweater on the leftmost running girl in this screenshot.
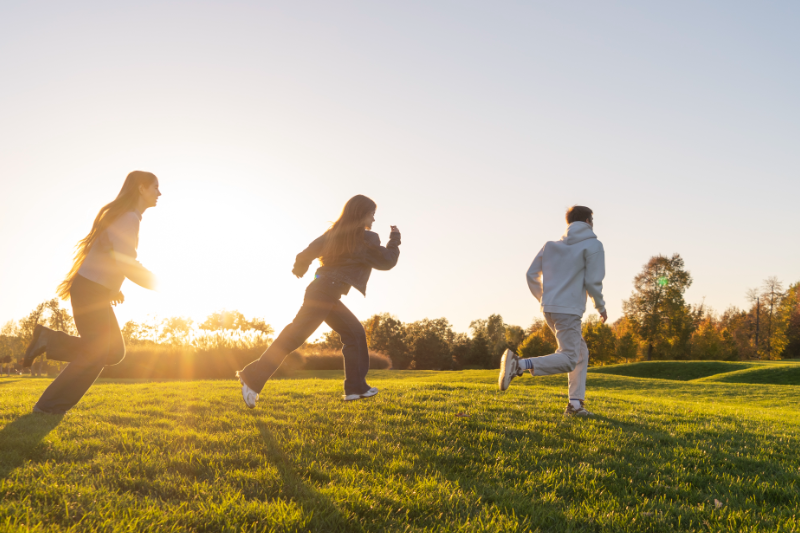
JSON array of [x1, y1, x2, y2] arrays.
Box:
[[78, 211, 156, 293]]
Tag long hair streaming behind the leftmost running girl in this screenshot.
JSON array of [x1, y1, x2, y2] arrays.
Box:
[[56, 170, 157, 300]]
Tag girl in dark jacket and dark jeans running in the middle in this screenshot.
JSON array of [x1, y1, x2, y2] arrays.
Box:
[[236, 194, 400, 409]]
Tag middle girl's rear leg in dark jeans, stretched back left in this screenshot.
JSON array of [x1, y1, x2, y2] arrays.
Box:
[[238, 278, 342, 393]]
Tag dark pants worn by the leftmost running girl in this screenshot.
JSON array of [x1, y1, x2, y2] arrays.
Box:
[[36, 276, 125, 413]]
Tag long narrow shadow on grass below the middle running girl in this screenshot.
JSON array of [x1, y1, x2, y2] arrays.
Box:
[[256, 421, 363, 532]]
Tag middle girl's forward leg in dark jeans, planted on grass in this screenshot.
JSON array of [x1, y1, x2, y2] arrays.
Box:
[[325, 301, 369, 395]]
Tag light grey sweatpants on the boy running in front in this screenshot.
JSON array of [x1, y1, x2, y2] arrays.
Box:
[[527, 313, 589, 400]]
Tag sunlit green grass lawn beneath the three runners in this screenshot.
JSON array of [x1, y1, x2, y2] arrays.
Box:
[[0, 371, 800, 532]]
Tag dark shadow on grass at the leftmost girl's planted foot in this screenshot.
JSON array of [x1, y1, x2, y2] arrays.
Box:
[[0, 413, 64, 479]]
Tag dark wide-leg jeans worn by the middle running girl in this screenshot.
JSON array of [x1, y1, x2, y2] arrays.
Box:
[[239, 278, 369, 394]]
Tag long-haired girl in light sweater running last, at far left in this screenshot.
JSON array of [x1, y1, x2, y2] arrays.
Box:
[[22, 170, 161, 414]]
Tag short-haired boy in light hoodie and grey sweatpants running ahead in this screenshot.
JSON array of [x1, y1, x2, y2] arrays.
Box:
[[498, 205, 608, 417]]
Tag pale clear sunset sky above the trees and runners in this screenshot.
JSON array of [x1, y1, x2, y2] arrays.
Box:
[[0, 0, 800, 333]]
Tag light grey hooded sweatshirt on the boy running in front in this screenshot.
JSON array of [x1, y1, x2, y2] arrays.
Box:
[[528, 222, 606, 316]]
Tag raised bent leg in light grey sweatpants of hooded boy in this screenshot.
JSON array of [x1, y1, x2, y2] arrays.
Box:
[[519, 313, 583, 376]]
